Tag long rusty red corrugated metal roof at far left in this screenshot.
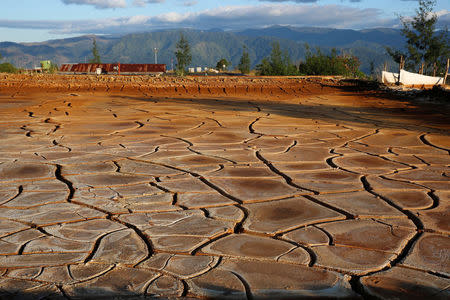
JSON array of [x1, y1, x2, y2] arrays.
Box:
[[59, 64, 166, 73]]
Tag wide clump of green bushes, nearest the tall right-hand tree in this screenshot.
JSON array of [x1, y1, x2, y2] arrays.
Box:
[[299, 45, 364, 78]]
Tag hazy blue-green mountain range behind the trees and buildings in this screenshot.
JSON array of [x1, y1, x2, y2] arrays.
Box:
[[0, 26, 404, 72]]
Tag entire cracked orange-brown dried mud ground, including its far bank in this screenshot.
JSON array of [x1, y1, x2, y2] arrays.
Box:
[[0, 75, 450, 299]]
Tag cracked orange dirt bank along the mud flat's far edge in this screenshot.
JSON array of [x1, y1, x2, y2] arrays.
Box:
[[0, 74, 338, 98]]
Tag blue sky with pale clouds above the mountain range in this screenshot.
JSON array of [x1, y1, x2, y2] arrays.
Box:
[[0, 0, 450, 42]]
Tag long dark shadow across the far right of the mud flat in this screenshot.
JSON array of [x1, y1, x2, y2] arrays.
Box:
[[111, 92, 450, 135]]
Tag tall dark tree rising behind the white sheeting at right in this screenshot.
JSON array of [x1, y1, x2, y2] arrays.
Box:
[[386, 0, 450, 72]]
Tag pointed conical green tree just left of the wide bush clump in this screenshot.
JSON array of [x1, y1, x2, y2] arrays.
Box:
[[256, 42, 298, 76]]
